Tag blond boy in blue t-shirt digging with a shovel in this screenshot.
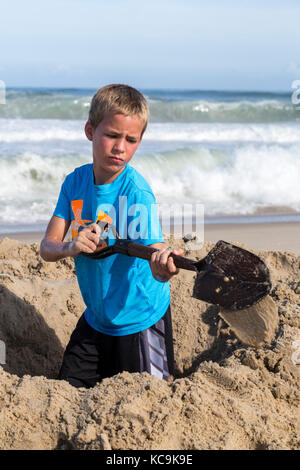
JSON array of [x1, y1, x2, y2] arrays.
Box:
[[40, 85, 183, 387]]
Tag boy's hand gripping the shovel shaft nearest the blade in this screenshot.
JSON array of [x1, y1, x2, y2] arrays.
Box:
[[150, 248, 184, 282]]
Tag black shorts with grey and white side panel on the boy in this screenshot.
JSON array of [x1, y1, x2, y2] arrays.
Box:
[[58, 307, 174, 388]]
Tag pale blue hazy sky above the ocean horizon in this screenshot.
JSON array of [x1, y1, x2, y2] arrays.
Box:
[[0, 0, 300, 91]]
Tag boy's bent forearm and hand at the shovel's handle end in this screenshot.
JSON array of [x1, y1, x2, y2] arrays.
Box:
[[40, 215, 101, 261]]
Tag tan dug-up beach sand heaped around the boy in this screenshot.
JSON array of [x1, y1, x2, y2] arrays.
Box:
[[0, 239, 300, 450]]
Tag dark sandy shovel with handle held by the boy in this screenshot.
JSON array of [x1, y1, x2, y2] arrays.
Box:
[[82, 221, 271, 310]]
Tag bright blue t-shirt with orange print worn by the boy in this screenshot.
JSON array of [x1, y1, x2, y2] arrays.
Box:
[[54, 164, 170, 336]]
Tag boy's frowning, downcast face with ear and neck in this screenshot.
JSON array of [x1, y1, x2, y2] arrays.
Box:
[[85, 113, 144, 184]]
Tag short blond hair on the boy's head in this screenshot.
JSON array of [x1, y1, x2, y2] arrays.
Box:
[[89, 84, 149, 135]]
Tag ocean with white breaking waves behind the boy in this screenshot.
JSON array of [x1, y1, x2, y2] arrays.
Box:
[[0, 88, 300, 233]]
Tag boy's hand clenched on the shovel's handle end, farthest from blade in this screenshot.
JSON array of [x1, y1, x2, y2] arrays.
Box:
[[69, 223, 104, 258]]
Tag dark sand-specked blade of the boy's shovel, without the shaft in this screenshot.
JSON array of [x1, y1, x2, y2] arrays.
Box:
[[193, 240, 271, 310]]
